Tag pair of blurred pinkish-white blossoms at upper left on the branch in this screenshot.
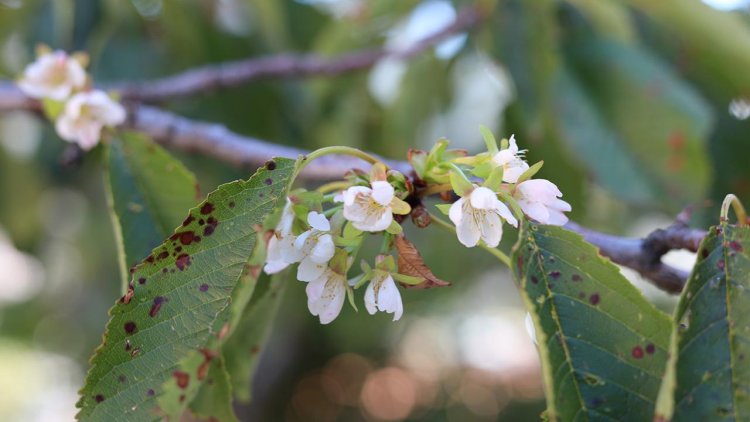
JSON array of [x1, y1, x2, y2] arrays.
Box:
[[18, 47, 126, 150]]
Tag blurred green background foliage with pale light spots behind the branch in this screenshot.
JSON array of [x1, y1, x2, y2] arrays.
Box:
[[0, 0, 750, 421]]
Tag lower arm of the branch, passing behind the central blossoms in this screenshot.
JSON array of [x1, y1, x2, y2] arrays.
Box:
[[0, 82, 705, 293]]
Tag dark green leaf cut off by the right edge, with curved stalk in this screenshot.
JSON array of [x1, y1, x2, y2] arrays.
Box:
[[657, 222, 750, 421]]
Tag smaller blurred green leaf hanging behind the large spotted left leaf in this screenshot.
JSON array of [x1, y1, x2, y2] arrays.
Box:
[[105, 132, 200, 293]]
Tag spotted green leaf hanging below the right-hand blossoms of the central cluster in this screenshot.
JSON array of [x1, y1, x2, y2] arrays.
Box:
[[512, 221, 670, 421]]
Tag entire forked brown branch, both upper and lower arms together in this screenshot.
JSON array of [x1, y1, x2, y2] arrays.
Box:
[[0, 1, 705, 293]]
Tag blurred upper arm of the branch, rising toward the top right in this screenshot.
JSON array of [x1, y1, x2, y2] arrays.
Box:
[[114, 7, 482, 102]]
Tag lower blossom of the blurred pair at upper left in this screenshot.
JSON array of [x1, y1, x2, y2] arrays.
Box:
[[55, 91, 125, 150]]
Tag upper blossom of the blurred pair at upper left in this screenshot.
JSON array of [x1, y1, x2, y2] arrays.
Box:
[[18, 50, 86, 101]]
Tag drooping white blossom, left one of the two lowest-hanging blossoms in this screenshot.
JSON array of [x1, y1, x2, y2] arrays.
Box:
[[305, 267, 347, 324]]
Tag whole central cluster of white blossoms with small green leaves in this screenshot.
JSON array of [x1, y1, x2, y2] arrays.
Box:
[[264, 128, 571, 324]]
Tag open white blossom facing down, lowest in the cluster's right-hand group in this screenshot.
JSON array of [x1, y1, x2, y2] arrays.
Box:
[[448, 187, 518, 248]]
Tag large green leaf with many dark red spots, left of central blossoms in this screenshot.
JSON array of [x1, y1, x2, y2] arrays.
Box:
[[78, 158, 297, 421]]
